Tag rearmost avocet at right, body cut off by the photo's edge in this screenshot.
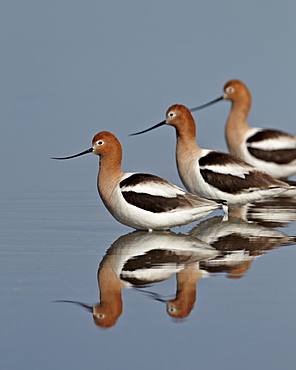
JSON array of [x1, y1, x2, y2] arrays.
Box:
[[191, 80, 296, 179]]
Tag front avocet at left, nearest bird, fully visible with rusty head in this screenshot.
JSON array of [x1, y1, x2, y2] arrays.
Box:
[[53, 131, 227, 231]]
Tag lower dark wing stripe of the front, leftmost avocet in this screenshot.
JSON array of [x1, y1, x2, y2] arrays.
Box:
[[122, 191, 190, 213]]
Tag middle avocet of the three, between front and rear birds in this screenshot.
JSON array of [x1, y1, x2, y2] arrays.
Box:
[[132, 104, 290, 207]]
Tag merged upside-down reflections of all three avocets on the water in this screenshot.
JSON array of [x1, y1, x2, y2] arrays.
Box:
[[55, 198, 296, 328]]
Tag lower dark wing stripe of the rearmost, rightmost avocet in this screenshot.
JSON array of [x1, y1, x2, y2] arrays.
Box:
[[248, 147, 296, 164]]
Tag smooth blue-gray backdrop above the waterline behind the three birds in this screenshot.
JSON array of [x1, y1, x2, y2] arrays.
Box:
[[0, 0, 296, 195]]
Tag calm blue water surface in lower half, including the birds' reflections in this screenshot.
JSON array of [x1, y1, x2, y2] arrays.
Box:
[[0, 191, 296, 369]]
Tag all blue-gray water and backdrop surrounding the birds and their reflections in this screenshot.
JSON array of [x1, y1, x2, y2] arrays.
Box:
[[0, 0, 296, 370]]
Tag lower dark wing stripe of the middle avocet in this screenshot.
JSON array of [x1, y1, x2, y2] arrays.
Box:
[[200, 169, 281, 194]]
